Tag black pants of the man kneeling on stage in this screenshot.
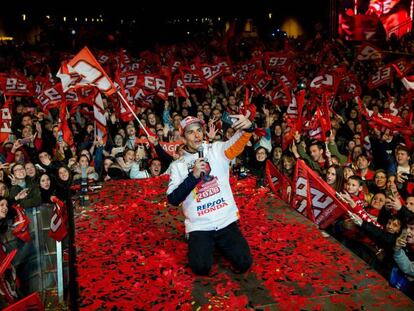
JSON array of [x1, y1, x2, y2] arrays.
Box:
[[188, 222, 253, 275]]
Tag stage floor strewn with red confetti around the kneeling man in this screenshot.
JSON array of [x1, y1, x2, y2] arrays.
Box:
[[75, 178, 414, 310]]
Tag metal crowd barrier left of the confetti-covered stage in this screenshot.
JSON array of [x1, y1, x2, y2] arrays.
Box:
[[3, 204, 69, 304]]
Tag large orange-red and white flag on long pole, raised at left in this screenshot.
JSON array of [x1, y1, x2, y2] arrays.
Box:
[[62, 47, 116, 96]]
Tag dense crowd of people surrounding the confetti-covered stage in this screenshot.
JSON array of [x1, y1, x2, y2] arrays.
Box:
[[0, 26, 414, 304]]
